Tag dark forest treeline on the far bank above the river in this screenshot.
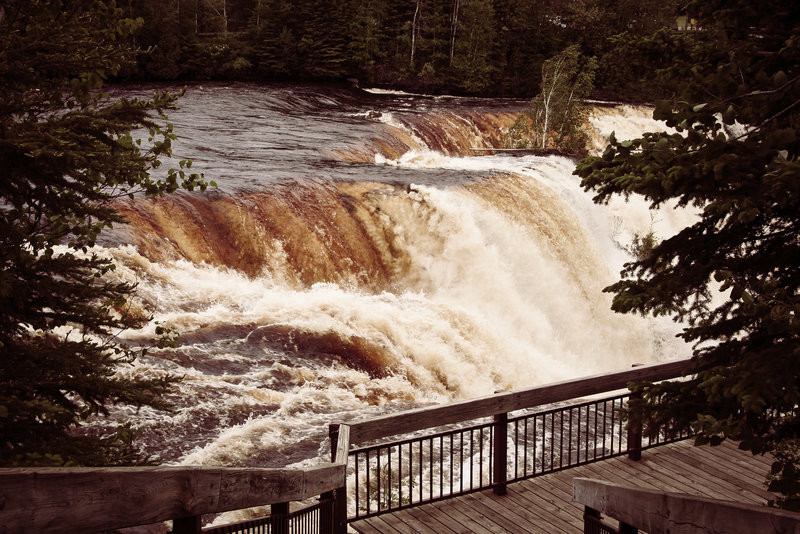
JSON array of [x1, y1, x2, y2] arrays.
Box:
[[119, 0, 680, 99]]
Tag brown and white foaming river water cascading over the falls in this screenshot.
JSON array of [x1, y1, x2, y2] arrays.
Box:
[[94, 85, 689, 466]]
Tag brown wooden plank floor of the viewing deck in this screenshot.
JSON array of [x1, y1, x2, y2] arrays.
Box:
[[350, 441, 771, 534]]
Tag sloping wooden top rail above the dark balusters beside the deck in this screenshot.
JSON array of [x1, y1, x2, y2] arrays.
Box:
[[350, 360, 692, 444]]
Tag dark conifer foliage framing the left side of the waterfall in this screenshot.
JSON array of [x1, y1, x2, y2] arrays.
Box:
[[0, 0, 206, 466]]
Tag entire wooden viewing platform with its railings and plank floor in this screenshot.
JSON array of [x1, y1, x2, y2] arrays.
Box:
[[0, 360, 800, 534]]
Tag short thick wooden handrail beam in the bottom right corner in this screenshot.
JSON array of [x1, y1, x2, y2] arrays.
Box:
[[572, 478, 800, 534]]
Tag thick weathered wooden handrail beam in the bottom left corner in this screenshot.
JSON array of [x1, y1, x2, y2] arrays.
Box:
[[0, 464, 346, 533]]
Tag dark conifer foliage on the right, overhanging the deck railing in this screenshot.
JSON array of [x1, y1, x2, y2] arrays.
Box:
[[576, 0, 800, 509]]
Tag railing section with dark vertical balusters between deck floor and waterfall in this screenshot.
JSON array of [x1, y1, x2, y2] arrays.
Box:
[[333, 360, 690, 521]]
